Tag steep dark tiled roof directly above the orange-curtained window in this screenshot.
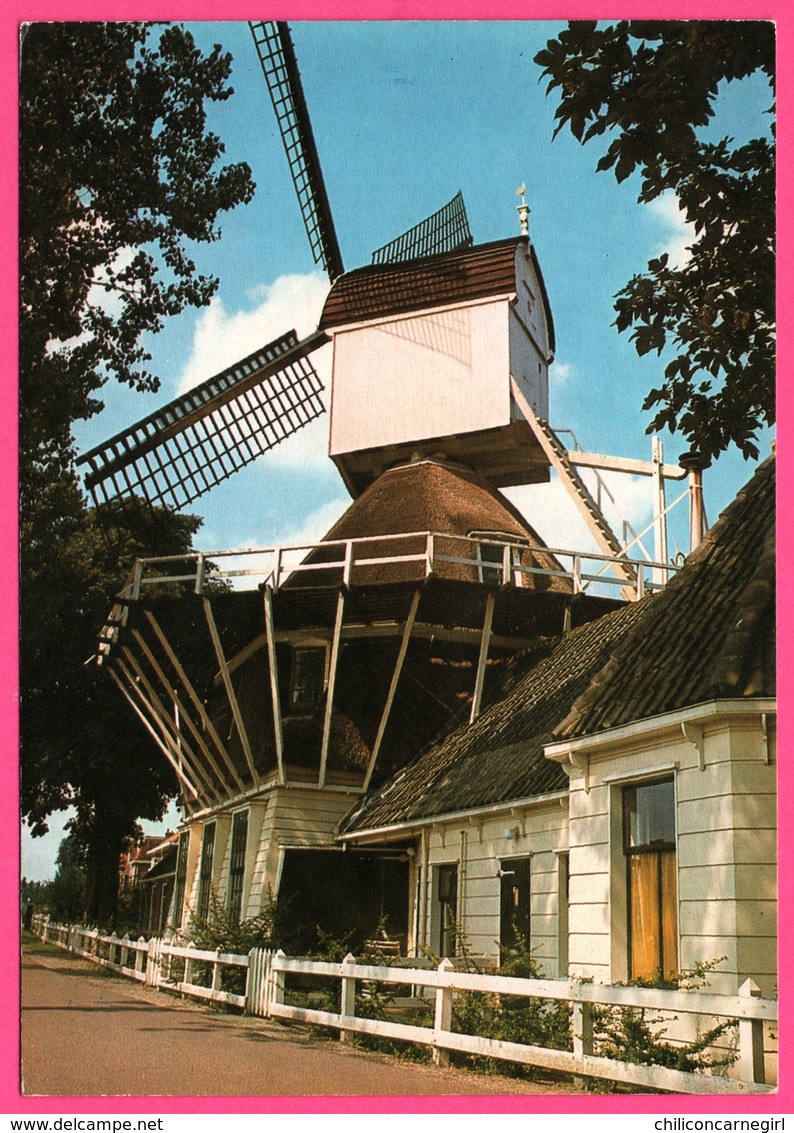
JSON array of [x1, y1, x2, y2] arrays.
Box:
[[555, 457, 775, 739]]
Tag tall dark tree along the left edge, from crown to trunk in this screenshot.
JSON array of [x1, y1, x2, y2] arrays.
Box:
[[19, 23, 254, 922]]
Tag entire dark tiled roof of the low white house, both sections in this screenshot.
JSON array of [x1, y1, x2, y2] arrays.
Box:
[[342, 458, 775, 833]]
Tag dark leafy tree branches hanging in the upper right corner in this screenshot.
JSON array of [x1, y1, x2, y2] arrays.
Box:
[[535, 20, 775, 460]]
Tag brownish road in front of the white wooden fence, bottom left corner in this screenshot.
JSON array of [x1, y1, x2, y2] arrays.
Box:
[[22, 949, 577, 1097]]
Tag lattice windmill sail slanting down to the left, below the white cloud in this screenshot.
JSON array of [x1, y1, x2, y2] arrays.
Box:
[[78, 331, 328, 508]]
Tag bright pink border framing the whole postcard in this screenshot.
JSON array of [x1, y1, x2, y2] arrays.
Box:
[[9, 0, 794, 1115]]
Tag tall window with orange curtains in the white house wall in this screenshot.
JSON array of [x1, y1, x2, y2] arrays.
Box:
[[623, 780, 678, 980]]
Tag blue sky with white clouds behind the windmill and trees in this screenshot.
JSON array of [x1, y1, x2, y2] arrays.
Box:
[[23, 20, 770, 876]]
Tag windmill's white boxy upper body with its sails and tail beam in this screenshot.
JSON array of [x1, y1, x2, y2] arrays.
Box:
[[78, 23, 681, 586]]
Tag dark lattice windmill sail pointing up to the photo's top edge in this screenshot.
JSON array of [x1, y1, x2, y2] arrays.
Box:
[[249, 22, 344, 283]]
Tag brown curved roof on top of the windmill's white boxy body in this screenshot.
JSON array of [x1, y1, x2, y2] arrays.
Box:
[[319, 236, 554, 349]]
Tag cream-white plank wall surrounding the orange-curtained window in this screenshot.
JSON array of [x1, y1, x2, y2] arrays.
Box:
[[569, 716, 777, 995]]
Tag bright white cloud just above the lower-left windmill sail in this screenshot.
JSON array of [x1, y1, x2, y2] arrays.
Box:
[[178, 275, 328, 393]]
